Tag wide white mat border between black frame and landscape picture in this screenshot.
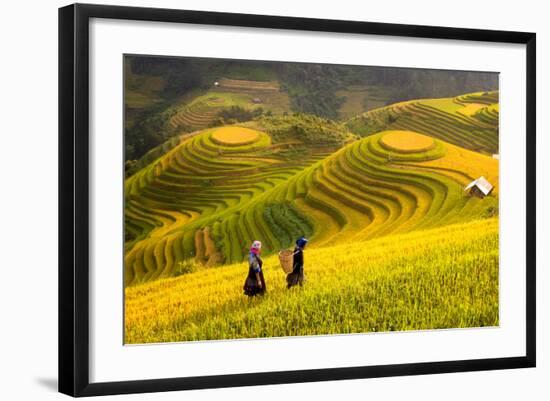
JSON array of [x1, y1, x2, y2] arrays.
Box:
[[90, 14, 525, 381]]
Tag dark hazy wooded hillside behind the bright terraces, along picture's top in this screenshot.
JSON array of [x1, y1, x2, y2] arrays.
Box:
[[124, 55, 498, 161]]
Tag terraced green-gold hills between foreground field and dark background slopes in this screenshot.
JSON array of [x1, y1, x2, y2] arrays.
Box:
[[125, 91, 498, 285]]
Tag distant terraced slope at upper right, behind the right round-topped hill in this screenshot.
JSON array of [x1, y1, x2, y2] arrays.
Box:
[[352, 92, 499, 155]]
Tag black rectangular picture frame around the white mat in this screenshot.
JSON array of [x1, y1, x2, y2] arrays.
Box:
[[58, 4, 536, 396]]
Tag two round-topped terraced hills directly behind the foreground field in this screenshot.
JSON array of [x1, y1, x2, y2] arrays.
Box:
[[125, 120, 498, 285]]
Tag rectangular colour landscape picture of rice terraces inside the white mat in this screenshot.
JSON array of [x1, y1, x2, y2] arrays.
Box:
[[124, 56, 500, 344]]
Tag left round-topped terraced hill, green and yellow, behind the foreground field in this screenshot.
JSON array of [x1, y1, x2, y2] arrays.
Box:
[[125, 127, 327, 284]]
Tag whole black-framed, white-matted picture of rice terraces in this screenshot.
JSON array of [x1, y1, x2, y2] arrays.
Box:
[[59, 4, 536, 396]]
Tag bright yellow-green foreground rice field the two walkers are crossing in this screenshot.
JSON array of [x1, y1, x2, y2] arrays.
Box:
[[125, 218, 499, 344]]
